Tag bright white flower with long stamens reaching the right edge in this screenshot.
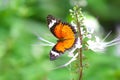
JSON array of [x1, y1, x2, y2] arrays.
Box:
[[87, 36, 120, 52]]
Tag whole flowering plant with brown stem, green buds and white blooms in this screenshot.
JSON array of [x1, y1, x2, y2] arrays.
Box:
[[38, 6, 120, 80]]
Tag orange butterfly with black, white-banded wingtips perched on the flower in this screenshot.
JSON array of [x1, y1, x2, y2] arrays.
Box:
[[47, 15, 76, 60]]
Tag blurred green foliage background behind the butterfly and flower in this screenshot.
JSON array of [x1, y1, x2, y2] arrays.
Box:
[[0, 0, 120, 80]]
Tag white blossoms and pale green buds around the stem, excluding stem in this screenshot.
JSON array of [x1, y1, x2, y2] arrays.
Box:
[[36, 7, 120, 68]]
